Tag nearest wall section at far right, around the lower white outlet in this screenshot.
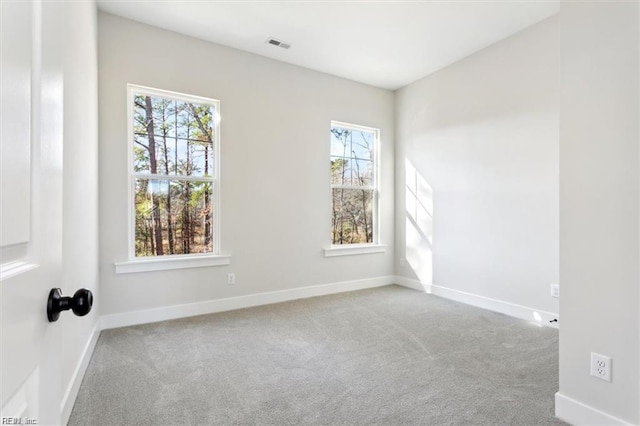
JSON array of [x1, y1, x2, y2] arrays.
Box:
[[556, 2, 640, 424]]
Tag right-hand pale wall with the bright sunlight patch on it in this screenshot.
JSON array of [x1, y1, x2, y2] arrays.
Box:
[[396, 18, 559, 322]]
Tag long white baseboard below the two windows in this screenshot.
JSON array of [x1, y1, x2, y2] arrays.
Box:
[[101, 276, 396, 330]]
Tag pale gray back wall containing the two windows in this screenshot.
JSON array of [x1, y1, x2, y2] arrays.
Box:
[[98, 13, 394, 314]]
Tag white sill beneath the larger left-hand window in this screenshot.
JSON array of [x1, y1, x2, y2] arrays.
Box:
[[115, 254, 231, 274]]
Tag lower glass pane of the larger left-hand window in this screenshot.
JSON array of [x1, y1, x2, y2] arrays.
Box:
[[135, 179, 214, 256]]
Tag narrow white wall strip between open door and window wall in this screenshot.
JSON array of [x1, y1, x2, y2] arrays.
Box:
[[55, 1, 100, 419]]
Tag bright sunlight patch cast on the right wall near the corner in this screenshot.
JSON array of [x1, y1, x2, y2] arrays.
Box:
[[405, 159, 433, 290]]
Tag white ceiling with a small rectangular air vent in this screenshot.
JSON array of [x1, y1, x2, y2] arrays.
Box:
[[98, 0, 560, 89]]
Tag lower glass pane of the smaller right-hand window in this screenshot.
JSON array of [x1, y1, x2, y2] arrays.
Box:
[[331, 188, 373, 244]]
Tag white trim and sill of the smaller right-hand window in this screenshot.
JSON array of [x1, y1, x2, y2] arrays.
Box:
[[324, 120, 380, 246]]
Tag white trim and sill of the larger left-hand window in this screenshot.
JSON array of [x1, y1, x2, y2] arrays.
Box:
[[119, 84, 231, 274]]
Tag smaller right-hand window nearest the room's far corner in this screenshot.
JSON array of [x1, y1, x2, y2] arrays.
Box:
[[331, 121, 379, 246]]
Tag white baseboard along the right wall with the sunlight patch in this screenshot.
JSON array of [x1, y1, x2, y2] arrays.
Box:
[[395, 276, 558, 328]]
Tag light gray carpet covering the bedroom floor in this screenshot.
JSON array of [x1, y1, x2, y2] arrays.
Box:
[[69, 286, 563, 425]]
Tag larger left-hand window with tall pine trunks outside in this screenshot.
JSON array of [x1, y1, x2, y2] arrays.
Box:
[[128, 85, 220, 259]]
